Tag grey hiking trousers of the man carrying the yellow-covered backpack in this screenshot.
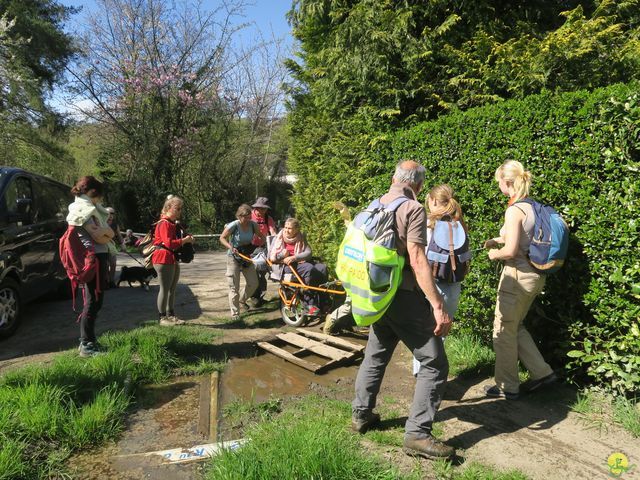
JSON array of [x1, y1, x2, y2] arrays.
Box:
[[352, 290, 449, 438]]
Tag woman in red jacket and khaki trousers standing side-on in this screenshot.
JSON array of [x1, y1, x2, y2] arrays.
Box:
[[152, 196, 193, 325]]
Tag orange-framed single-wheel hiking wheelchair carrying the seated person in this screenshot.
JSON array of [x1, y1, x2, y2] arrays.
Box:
[[240, 249, 346, 327]]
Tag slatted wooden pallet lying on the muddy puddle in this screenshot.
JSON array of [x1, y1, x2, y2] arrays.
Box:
[[258, 328, 364, 373]]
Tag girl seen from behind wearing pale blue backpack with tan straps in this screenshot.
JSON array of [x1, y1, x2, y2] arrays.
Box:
[[413, 184, 471, 375]]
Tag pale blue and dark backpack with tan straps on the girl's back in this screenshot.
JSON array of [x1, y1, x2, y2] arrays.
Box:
[[427, 220, 471, 283]]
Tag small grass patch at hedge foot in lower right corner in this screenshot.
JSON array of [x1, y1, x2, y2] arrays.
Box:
[[571, 390, 640, 438]]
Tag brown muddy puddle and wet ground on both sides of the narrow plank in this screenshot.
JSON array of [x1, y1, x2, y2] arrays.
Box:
[[71, 338, 359, 480]]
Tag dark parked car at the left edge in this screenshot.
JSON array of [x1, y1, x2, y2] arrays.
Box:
[[0, 167, 73, 338]]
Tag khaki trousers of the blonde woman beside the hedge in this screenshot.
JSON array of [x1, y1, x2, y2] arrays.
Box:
[[493, 265, 553, 393]]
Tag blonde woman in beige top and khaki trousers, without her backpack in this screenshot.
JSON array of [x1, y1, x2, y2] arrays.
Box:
[[484, 160, 557, 400]]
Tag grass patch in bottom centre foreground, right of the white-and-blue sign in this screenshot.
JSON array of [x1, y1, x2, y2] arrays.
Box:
[[206, 396, 420, 480]]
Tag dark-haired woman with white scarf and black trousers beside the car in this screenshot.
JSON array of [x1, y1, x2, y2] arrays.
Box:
[[67, 176, 114, 357]]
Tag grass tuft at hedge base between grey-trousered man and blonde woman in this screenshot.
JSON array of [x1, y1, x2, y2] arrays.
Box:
[[445, 333, 496, 376]]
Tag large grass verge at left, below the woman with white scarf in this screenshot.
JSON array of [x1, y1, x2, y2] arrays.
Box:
[[0, 326, 224, 480]]
